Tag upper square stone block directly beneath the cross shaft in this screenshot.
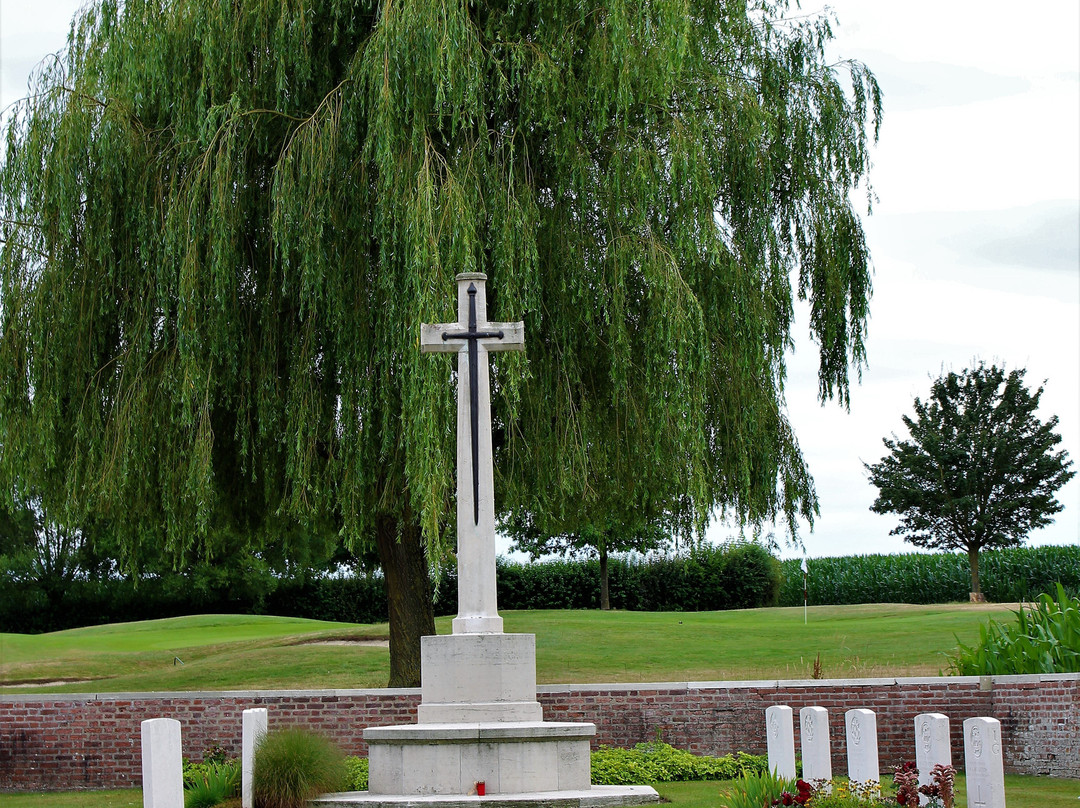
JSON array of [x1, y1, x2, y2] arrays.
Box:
[[417, 634, 543, 724]]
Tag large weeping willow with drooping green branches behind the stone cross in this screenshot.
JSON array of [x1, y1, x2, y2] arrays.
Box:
[[0, 0, 880, 685]]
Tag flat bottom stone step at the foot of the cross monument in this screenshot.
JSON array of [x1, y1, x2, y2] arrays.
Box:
[[308, 785, 660, 808]]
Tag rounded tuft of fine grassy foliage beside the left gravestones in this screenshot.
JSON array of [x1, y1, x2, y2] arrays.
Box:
[[252, 727, 348, 808]]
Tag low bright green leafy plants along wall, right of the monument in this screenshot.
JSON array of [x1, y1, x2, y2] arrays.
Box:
[[592, 741, 767, 785]]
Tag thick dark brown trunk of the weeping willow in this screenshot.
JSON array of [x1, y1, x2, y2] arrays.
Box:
[[375, 516, 435, 687]]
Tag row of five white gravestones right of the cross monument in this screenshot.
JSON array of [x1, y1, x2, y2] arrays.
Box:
[[765, 704, 1005, 808]]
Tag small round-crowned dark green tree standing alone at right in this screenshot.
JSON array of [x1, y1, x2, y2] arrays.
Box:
[[866, 363, 1075, 600]]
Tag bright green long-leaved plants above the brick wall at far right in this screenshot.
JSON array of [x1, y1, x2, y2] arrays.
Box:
[[949, 583, 1080, 676]]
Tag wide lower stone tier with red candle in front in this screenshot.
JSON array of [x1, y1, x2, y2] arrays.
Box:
[[364, 722, 596, 796]]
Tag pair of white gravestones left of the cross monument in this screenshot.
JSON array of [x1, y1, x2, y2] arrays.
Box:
[[141, 708, 267, 808]]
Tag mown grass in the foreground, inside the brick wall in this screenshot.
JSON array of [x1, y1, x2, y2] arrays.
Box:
[[3, 775, 1080, 808]]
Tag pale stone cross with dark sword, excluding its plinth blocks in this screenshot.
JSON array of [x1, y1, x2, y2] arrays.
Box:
[[420, 272, 525, 634]]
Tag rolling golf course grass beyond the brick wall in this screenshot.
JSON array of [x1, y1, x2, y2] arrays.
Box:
[[0, 604, 1010, 692]]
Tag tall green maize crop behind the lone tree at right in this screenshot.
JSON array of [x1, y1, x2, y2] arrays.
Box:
[[780, 544, 1080, 606]]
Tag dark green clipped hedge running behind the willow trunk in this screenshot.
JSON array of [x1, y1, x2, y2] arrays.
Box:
[[0, 544, 780, 633]]
